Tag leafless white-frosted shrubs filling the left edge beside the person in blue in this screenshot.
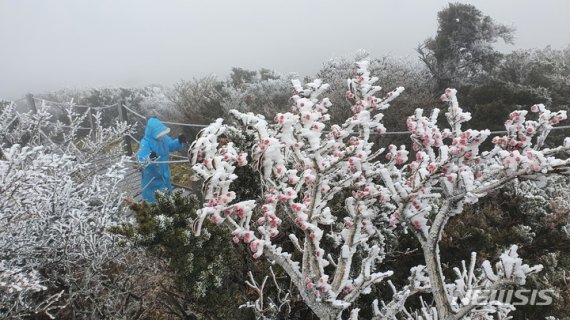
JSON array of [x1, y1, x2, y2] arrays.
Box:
[[0, 100, 164, 319]]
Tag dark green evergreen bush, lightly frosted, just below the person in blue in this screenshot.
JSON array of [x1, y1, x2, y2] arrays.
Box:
[[114, 192, 252, 319]]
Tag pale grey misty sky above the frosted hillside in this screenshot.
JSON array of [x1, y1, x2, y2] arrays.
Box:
[[0, 0, 570, 99]]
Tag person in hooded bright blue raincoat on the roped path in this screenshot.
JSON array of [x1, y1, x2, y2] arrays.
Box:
[[137, 117, 187, 203]]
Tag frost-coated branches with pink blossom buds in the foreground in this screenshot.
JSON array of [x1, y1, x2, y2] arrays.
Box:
[[189, 62, 570, 319]]
